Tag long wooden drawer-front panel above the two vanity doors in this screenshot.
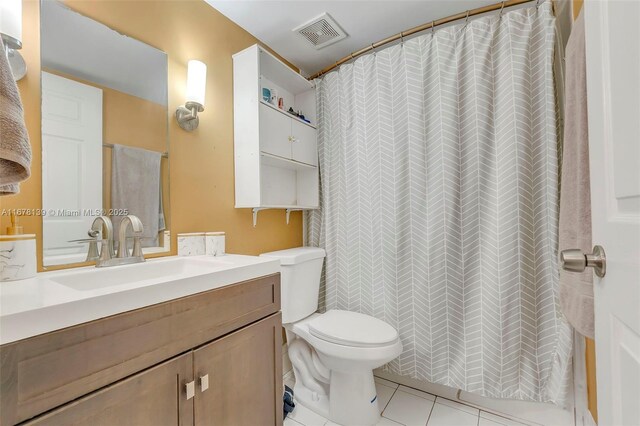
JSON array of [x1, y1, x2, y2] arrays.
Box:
[[0, 274, 280, 425]]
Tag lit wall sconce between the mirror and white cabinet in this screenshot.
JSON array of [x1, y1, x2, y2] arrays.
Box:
[[176, 60, 207, 132]]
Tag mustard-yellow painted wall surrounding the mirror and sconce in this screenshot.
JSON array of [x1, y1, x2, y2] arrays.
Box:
[[0, 0, 302, 270]]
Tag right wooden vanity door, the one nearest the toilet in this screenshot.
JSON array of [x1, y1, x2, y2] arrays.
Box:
[[193, 313, 282, 426]]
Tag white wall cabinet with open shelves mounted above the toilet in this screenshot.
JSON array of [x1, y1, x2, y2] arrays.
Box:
[[233, 45, 319, 223]]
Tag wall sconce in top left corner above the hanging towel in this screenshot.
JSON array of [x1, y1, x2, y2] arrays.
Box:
[[0, 0, 27, 81]]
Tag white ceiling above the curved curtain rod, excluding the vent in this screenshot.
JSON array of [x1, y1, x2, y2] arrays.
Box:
[[205, 0, 497, 75]]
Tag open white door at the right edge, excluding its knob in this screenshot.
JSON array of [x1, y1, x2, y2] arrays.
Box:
[[584, 0, 640, 426]]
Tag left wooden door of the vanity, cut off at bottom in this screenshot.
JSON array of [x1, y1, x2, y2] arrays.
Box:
[[25, 352, 193, 426]]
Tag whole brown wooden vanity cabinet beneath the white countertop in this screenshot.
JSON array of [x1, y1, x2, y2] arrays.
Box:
[[0, 274, 282, 426]]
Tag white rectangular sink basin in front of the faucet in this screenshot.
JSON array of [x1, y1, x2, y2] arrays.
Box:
[[50, 257, 233, 291]]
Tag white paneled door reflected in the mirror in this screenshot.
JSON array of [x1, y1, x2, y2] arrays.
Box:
[[42, 72, 102, 265]]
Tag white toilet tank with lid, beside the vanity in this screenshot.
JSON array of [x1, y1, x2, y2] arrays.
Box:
[[260, 247, 325, 324]]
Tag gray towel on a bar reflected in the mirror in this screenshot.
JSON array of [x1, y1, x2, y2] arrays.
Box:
[[111, 145, 162, 247]]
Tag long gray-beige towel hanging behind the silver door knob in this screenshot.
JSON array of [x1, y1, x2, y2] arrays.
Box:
[[558, 13, 594, 338]]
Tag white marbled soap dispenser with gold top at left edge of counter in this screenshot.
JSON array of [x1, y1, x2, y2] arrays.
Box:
[[0, 213, 37, 281]]
